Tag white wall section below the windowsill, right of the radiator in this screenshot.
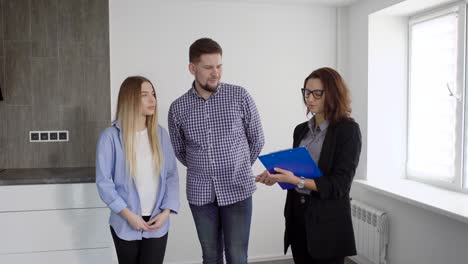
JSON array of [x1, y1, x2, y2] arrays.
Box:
[[352, 185, 468, 264]]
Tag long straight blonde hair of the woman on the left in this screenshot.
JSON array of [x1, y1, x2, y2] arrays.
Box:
[[116, 76, 163, 177]]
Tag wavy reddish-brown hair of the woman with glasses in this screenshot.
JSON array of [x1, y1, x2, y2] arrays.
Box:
[[303, 67, 351, 123]]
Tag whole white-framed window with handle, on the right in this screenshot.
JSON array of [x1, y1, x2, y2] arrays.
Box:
[[406, 3, 468, 190]]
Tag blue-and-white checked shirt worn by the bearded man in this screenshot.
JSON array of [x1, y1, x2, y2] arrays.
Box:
[[168, 83, 264, 206]]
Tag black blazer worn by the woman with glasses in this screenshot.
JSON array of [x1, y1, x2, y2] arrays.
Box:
[[284, 119, 361, 259]]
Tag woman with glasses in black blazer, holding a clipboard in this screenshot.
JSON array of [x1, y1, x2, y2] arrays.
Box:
[[256, 68, 361, 264]]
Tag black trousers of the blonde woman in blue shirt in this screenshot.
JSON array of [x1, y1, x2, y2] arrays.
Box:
[[110, 216, 168, 264]]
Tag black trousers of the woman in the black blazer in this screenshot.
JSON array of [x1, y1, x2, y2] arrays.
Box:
[[290, 192, 344, 264]]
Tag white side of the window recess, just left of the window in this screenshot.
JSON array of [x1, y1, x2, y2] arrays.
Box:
[[367, 14, 408, 182]]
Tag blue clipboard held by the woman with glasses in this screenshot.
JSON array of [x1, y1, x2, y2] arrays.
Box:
[[258, 147, 322, 190]]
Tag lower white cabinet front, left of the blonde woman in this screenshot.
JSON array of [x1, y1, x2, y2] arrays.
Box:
[[0, 208, 112, 254]]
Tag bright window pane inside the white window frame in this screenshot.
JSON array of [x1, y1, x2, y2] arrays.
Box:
[[407, 14, 461, 182]]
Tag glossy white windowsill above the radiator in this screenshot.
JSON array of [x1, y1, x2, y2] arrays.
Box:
[[354, 179, 468, 224]]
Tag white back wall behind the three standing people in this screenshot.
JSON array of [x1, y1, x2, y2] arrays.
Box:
[[110, 0, 337, 263]]
